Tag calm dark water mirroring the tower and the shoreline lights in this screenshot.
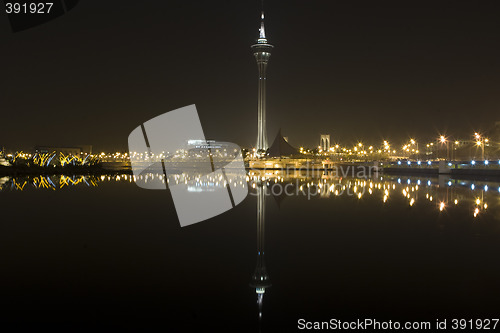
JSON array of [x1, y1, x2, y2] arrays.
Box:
[[0, 174, 500, 332]]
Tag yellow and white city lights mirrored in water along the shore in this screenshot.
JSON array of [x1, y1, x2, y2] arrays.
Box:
[[0, 170, 500, 222]]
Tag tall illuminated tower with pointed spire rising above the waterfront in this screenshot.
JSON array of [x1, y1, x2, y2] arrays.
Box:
[[252, 6, 274, 154]]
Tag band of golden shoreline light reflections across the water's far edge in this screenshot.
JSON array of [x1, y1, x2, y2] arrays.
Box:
[[0, 170, 500, 217]]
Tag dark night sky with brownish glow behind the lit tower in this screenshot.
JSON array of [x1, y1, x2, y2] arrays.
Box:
[[0, 0, 500, 150]]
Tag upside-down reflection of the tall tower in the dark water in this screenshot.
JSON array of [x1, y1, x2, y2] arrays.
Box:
[[250, 182, 271, 327]]
